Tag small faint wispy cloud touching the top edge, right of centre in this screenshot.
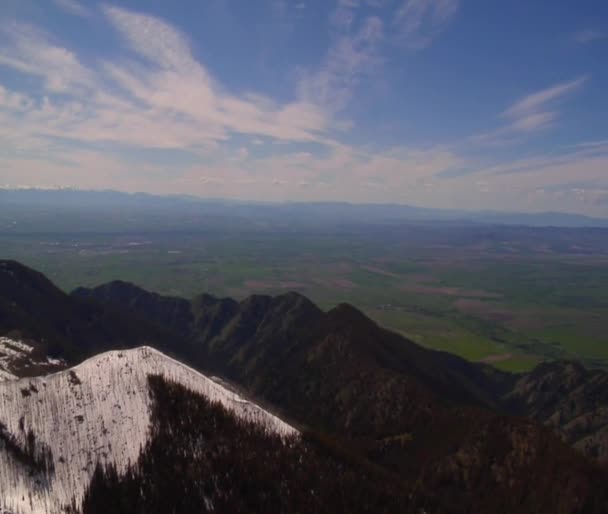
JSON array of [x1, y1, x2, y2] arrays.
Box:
[[393, 0, 459, 49]]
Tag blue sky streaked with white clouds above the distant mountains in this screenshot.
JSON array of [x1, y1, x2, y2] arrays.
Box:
[[0, 0, 608, 212]]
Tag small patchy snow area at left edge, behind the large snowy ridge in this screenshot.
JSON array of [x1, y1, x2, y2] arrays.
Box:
[[0, 337, 65, 380]]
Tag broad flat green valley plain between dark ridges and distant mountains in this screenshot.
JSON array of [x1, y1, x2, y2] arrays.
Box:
[[0, 227, 608, 371]]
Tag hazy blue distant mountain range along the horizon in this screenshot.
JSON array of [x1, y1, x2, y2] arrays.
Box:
[[0, 188, 608, 228]]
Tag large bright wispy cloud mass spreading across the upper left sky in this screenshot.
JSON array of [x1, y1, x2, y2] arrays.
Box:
[[0, 7, 329, 154]]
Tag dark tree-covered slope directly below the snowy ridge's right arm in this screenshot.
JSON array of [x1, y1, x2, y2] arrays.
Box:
[[78, 376, 420, 514]]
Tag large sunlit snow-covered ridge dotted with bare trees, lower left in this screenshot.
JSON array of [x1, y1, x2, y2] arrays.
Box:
[[0, 347, 297, 514]]
